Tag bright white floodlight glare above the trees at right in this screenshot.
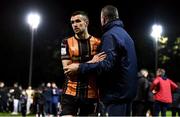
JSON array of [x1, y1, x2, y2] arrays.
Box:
[[151, 24, 162, 39]]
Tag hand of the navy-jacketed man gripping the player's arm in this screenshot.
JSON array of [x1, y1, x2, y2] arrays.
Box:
[[64, 63, 79, 77]]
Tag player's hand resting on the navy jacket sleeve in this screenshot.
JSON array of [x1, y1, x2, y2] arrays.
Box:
[[87, 52, 107, 63]]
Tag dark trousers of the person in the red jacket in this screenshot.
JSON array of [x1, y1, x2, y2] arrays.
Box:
[[153, 101, 169, 116]]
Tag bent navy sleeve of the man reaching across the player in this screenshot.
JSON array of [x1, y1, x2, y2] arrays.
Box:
[[79, 35, 117, 74]]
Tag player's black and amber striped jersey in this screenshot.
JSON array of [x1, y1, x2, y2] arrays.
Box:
[[61, 36, 100, 98]]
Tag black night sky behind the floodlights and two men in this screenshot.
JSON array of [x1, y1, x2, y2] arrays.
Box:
[[0, 0, 180, 88]]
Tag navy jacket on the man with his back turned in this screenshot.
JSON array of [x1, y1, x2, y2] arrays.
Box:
[[79, 20, 137, 103]]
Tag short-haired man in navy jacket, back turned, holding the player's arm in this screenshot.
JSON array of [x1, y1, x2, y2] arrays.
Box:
[[64, 5, 137, 116]]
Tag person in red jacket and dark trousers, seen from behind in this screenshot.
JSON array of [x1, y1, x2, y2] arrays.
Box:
[[151, 68, 177, 116]]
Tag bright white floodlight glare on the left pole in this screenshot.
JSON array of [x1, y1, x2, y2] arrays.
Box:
[[27, 13, 41, 29]]
